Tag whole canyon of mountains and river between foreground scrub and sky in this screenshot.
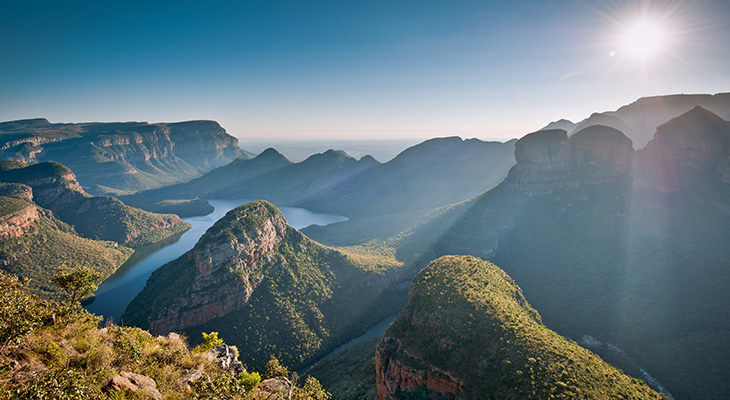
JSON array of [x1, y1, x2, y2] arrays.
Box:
[[0, 94, 730, 400]]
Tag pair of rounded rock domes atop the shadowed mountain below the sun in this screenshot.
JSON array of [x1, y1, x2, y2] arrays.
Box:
[[508, 125, 634, 194]]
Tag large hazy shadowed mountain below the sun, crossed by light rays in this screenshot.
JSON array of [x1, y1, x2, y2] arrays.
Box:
[[399, 108, 730, 399]]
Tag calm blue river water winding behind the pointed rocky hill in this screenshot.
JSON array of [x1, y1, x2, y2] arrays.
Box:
[[86, 199, 347, 321]]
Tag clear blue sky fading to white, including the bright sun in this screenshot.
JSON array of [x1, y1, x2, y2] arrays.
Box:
[[0, 0, 730, 141]]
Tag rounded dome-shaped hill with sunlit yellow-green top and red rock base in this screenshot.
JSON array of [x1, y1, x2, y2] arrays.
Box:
[[376, 256, 664, 400]]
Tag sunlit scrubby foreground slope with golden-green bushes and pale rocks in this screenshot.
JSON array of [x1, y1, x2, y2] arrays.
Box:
[[0, 271, 330, 400]]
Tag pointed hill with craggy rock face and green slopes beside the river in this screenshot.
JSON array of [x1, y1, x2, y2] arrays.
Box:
[[122, 200, 412, 368]]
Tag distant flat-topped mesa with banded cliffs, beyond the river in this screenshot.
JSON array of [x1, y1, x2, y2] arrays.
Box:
[[0, 120, 245, 192]]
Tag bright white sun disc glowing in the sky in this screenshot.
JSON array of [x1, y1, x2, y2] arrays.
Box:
[[620, 20, 667, 60]]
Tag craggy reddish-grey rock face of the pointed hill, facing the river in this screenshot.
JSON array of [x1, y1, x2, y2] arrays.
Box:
[[149, 202, 288, 334]]
